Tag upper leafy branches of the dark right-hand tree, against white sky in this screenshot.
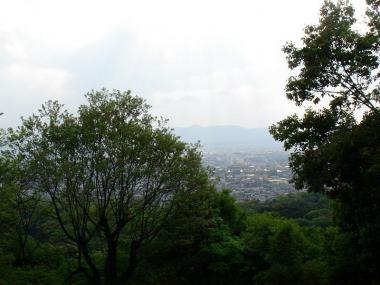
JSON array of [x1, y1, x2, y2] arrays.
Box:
[[283, 1, 379, 111]]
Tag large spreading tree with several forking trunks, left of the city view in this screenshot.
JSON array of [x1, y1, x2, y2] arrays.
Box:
[[8, 89, 208, 284]]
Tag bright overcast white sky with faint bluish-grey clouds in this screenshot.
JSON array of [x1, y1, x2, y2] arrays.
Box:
[[0, 0, 365, 128]]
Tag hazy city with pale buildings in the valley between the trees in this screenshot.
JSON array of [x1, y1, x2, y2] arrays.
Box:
[[203, 150, 296, 202]]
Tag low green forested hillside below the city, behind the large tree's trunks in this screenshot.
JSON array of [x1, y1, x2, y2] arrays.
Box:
[[0, 154, 345, 284]]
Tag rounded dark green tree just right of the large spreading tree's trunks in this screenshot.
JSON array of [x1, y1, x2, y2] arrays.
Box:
[[137, 187, 244, 284]]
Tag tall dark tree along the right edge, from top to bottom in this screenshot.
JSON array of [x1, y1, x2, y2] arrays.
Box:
[[270, 0, 380, 284]]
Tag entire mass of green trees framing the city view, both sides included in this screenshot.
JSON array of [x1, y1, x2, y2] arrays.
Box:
[[0, 0, 380, 285]]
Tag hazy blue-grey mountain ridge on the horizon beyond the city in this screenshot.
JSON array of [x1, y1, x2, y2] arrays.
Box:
[[174, 126, 282, 150]]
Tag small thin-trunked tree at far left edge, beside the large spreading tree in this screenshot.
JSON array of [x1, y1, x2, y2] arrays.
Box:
[[0, 156, 55, 269]]
